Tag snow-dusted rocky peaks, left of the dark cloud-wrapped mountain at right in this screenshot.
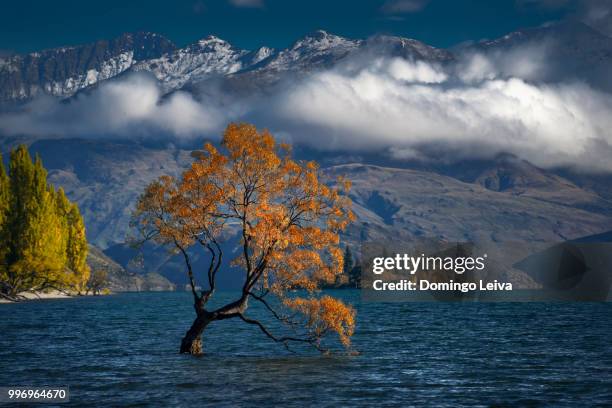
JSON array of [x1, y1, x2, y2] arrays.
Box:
[[0, 30, 452, 106]]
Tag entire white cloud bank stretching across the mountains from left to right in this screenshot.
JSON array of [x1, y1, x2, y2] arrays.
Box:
[[0, 49, 612, 171]]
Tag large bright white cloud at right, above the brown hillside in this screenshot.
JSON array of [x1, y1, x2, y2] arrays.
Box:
[[275, 56, 612, 171]]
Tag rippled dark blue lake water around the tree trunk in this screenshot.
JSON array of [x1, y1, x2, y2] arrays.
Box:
[[0, 291, 612, 407]]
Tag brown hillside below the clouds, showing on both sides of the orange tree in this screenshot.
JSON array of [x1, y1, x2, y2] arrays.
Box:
[[7, 139, 612, 287]]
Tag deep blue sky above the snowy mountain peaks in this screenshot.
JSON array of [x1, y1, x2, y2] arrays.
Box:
[[0, 0, 575, 52]]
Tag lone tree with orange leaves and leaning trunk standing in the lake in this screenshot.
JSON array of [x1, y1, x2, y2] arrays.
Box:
[[134, 124, 355, 354]]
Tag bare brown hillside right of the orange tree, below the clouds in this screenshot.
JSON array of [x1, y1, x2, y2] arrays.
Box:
[[326, 164, 612, 242]]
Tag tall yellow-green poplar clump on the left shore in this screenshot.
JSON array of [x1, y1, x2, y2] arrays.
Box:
[[0, 146, 89, 297]]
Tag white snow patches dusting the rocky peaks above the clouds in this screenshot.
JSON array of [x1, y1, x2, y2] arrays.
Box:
[[0, 30, 456, 102]]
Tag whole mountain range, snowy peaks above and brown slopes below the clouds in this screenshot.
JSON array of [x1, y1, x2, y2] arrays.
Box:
[[0, 23, 612, 287]]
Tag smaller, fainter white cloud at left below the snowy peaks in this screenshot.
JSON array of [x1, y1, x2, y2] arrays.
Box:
[[0, 74, 225, 138]]
